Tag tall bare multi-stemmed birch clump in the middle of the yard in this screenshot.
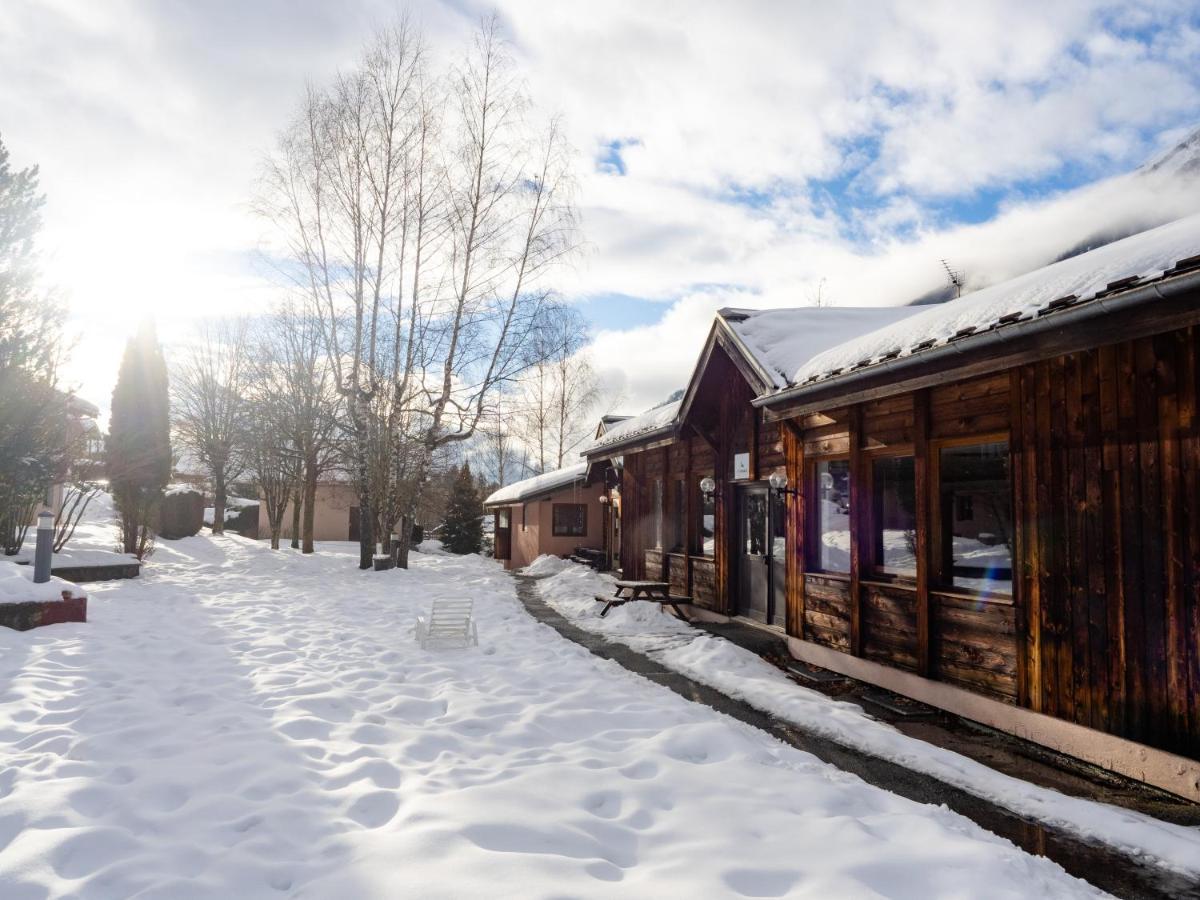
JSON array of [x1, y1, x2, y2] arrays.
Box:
[[260, 18, 575, 568]]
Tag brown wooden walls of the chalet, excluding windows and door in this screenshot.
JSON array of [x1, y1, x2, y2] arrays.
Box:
[[623, 314, 1200, 757]]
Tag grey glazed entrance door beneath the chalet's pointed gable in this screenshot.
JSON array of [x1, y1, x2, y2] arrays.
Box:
[[737, 485, 787, 628]]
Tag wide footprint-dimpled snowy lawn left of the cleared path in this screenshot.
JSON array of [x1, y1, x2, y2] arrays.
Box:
[[0, 535, 1132, 900]]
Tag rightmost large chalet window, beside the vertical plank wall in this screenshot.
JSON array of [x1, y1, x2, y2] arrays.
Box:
[[938, 440, 1013, 594]]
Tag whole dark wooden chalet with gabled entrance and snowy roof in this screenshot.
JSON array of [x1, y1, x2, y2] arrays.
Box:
[[586, 216, 1200, 800]]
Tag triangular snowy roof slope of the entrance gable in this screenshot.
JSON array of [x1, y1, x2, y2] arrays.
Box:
[[719, 306, 922, 388]]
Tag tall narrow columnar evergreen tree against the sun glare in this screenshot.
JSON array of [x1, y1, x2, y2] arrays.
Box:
[[107, 323, 170, 559]]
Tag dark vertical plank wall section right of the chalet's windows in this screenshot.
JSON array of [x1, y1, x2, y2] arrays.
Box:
[[1013, 329, 1200, 756]]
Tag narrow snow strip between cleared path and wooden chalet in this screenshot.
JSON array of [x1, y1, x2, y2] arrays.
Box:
[[535, 557, 1200, 878]]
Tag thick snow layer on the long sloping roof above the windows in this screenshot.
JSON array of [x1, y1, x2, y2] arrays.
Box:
[[791, 215, 1200, 385]]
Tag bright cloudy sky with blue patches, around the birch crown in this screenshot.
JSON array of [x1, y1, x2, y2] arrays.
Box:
[[0, 0, 1200, 422]]
